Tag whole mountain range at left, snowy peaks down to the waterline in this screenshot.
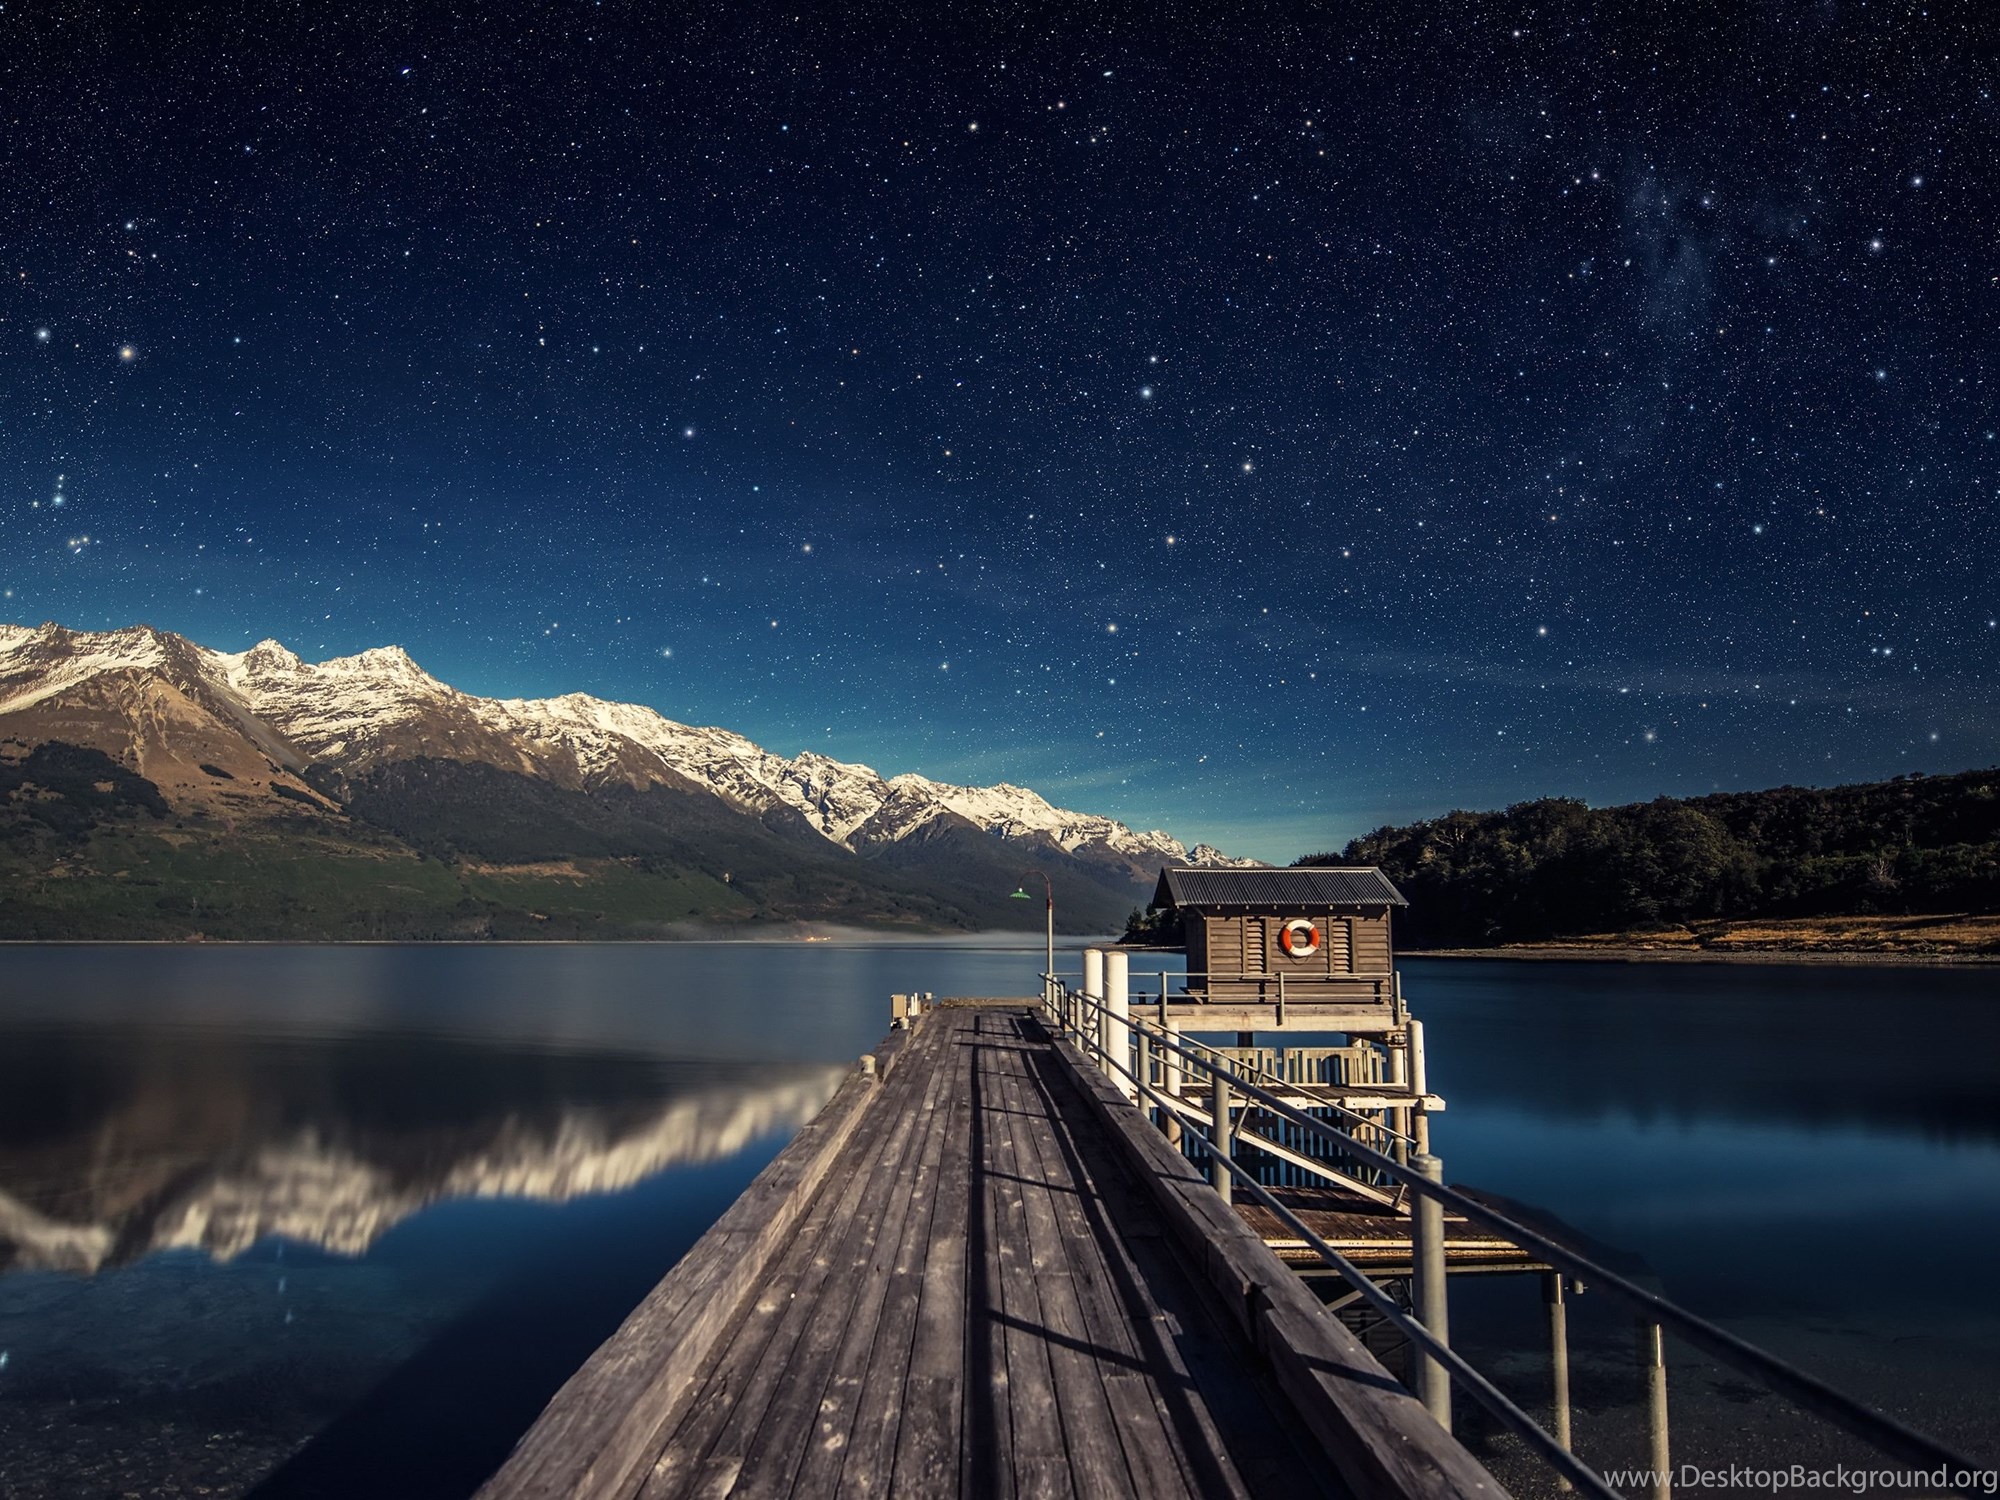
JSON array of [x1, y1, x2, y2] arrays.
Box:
[[0, 624, 1254, 938]]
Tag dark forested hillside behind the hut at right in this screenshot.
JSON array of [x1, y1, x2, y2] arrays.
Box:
[[1298, 768, 2000, 948]]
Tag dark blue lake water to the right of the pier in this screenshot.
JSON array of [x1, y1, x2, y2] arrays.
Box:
[[1404, 960, 2000, 1494]]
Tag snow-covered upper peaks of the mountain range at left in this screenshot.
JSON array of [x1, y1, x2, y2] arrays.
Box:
[[0, 624, 1256, 878]]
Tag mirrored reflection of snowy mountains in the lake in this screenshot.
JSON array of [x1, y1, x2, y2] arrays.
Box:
[[0, 1032, 840, 1272]]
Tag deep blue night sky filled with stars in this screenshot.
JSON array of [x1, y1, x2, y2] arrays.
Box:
[[0, 0, 2000, 858]]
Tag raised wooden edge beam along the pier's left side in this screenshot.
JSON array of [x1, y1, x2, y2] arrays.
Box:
[[478, 1032, 906, 1500]]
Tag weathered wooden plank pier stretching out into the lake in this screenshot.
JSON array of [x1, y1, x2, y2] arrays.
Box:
[[480, 1002, 1502, 1500]]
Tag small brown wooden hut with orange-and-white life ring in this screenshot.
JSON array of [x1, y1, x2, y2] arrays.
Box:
[[1152, 866, 1408, 1006]]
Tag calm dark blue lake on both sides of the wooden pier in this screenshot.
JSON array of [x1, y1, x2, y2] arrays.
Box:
[[0, 942, 2000, 1498]]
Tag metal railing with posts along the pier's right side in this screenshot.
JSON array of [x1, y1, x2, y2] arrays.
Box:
[[1042, 968, 1986, 1500]]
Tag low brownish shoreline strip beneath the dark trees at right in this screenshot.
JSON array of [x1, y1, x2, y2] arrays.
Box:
[[1402, 912, 2000, 968]]
